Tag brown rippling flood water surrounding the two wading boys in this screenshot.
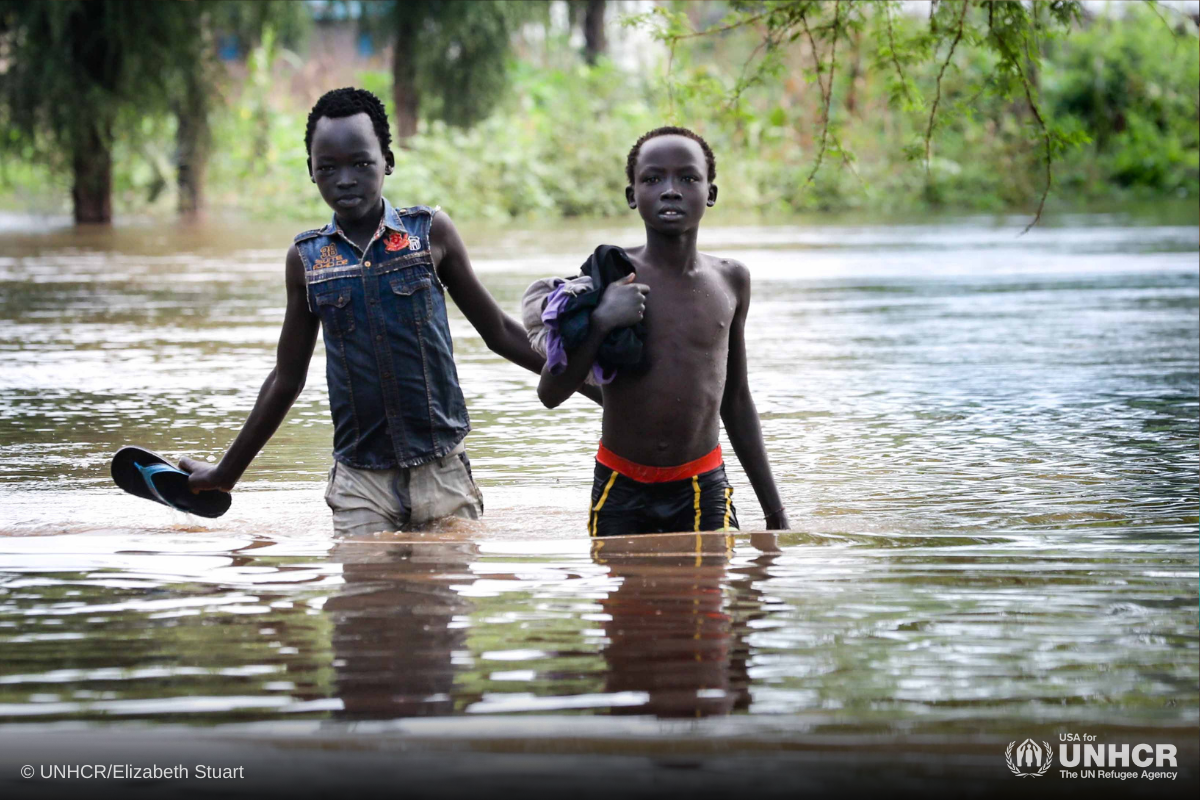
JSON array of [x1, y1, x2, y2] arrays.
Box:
[[0, 209, 1200, 739]]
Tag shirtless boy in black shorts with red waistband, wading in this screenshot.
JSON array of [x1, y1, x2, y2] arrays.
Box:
[[538, 127, 787, 536]]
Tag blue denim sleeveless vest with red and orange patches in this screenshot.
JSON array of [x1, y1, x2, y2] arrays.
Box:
[[295, 199, 470, 469]]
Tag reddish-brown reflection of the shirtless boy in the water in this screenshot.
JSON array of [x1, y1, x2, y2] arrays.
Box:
[[592, 534, 778, 717]]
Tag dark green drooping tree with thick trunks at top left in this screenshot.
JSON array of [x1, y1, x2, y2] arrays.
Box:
[[0, 0, 299, 224]]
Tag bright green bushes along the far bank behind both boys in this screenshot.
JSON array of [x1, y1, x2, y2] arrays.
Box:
[[0, 2, 1200, 219]]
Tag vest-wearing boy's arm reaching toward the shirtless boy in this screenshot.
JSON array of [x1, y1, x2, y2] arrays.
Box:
[[430, 212, 600, 403]]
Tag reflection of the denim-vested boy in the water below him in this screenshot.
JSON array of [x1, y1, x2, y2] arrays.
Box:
[[325, 534, 479, 720]]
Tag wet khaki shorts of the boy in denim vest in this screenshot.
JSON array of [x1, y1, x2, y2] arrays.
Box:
[[325, 443, 484, 535]]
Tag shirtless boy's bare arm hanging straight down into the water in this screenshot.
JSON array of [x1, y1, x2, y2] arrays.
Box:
[[721, 261, 787, 530]]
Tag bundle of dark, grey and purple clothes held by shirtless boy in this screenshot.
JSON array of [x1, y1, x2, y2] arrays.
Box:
[[521, 245, 649, 386]]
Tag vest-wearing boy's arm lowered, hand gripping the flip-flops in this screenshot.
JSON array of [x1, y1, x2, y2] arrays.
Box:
[[179, 245, 320, 492]]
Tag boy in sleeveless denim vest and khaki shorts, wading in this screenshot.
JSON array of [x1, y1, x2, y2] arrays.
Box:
[[179, 89, 592, 534]]
